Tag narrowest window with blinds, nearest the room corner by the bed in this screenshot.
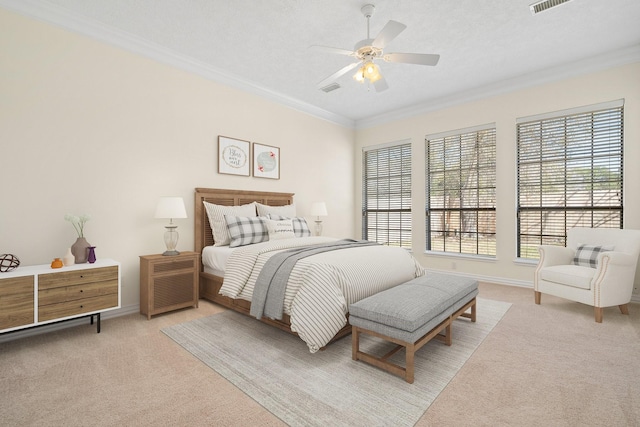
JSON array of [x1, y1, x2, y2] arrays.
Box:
[[362, 141, 411, 248]]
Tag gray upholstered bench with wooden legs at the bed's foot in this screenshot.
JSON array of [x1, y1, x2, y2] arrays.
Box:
[[349, 273, 478, 383]]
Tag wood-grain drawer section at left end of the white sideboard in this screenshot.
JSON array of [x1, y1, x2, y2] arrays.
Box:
[[0, 276, 35, 329]]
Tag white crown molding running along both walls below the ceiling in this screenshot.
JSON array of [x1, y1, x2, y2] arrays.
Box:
[[0, 0, 640, 130]]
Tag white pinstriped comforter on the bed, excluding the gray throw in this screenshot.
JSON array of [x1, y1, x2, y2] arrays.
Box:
[[220, 237, 424, 353]]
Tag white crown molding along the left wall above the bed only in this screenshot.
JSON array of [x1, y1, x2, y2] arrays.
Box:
[[0, 0, 355, 129]]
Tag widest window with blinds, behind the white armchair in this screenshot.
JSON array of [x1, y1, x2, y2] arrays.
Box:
[[517, 100, 623, 258]]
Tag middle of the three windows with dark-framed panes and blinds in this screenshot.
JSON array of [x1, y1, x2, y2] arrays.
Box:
[[425, 124, 496, 257]]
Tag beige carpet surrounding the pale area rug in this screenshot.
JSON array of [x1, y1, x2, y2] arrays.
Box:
[[0, 283, 640, 427]]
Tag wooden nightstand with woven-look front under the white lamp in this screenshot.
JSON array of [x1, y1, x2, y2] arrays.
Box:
[[140, 252, 200, 319]]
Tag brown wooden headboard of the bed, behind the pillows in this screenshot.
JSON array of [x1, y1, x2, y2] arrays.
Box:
[[194, 188, 294, 253]]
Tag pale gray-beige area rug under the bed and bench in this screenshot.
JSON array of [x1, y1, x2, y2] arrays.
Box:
[[162, 298, 511, 426]]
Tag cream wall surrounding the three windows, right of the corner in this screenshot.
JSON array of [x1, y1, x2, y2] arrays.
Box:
[[355, 63, 640, 295]]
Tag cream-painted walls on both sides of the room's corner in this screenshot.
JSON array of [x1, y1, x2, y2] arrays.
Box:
[[0, 5, 640, 309]]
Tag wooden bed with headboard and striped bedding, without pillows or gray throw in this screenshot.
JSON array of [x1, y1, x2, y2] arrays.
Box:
[[195, 188, 424, 352]]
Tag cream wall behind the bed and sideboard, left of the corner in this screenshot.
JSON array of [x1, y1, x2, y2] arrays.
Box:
[[0, 9, 355, 307]]
